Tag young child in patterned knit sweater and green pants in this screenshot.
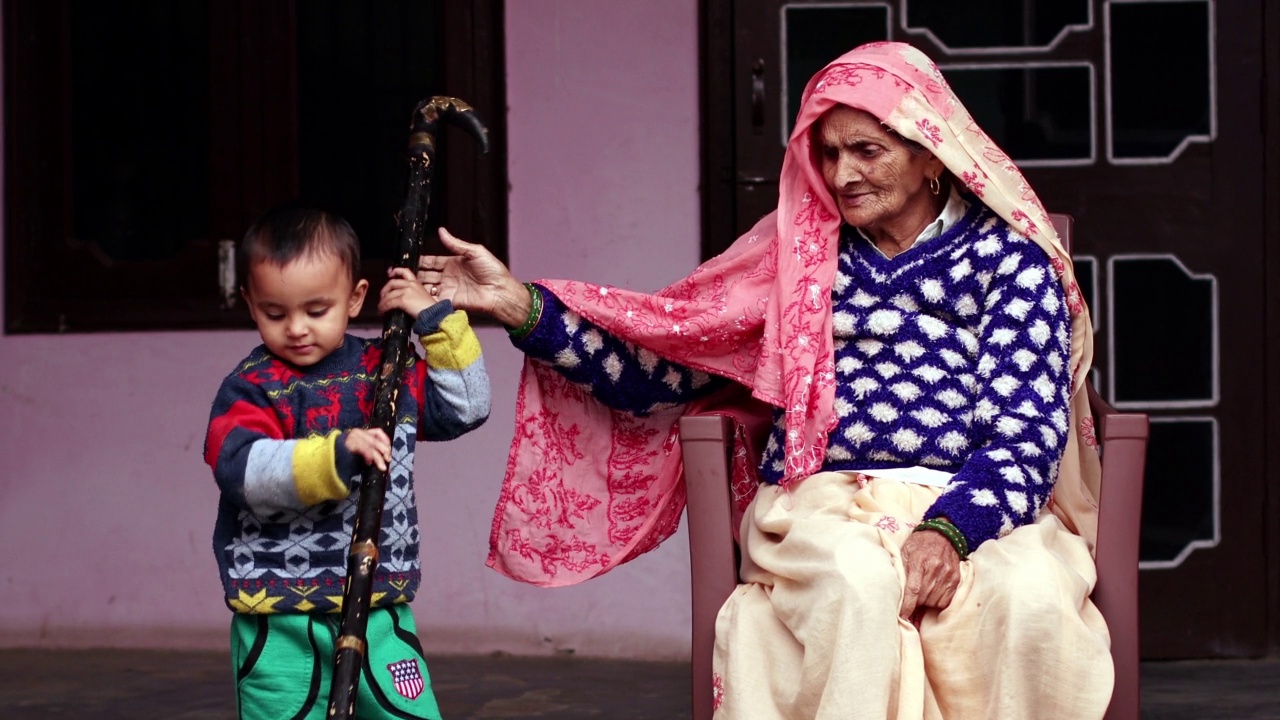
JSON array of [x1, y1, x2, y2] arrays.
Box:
[[205, 205, 489, 720]]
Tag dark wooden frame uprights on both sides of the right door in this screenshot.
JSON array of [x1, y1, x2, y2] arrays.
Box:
[[698, 0, 1280, 656]]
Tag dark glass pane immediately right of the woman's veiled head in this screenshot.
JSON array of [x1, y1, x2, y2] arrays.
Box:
[[942, 65, 1093, 163]]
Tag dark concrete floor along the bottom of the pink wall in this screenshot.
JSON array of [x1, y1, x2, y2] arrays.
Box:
[[0, 650, 1280, 720]]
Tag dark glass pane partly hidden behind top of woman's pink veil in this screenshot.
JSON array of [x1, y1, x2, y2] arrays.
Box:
[[782, 5, 890, 145]]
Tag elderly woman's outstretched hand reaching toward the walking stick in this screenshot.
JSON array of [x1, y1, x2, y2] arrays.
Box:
[[417, 228, 532, 328]]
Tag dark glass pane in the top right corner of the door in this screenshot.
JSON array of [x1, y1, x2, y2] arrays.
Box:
[[1107, 1, 1213, 159]]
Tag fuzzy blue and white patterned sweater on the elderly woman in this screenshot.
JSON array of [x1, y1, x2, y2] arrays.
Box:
[[513, 202, 1070, 548]]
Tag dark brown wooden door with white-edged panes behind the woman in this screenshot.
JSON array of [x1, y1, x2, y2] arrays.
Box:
[[703, 0, 1275, 659]]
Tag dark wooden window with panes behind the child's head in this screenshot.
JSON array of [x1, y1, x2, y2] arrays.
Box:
[[0, 0, 507, 333]]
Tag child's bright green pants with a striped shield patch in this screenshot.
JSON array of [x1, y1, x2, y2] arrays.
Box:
[[232, 605, 440, 720]]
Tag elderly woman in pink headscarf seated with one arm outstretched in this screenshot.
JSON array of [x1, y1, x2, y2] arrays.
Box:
[[420, 44, 1112, 720]]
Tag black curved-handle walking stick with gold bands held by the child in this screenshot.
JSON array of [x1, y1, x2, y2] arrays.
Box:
[[328, 95, 489, 719]]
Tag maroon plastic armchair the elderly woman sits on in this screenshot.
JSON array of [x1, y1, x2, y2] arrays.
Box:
[[680, 215, 1149, 720]]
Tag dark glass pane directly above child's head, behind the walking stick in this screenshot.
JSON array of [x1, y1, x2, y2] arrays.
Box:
[[297, 0, 448, 259]]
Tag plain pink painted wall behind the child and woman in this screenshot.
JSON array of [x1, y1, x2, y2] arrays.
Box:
[[0, 0, 699, 659]]
